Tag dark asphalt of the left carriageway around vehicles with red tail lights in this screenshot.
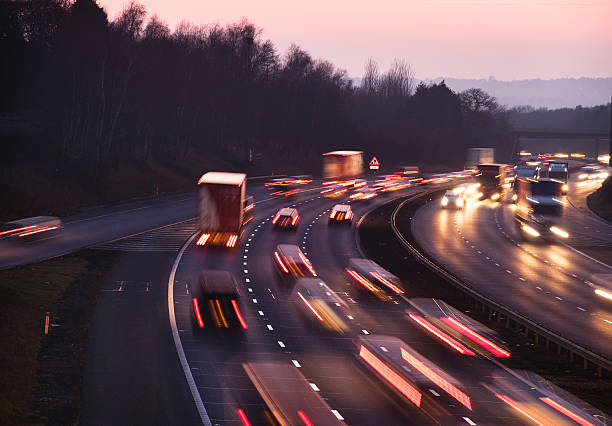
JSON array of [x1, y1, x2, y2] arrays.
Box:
[[172, 187, 600, 424]]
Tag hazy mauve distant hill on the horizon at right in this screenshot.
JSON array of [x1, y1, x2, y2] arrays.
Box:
[[425, 77, 612, 109]]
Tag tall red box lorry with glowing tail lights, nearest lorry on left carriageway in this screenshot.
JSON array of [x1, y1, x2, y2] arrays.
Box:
[[196, 172, 246, 247]]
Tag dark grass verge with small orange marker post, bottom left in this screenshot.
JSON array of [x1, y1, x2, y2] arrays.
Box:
[[0, 251, 112, 425]]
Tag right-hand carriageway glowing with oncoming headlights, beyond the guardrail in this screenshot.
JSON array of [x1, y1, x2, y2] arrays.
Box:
[[412, 173, 612, 366]]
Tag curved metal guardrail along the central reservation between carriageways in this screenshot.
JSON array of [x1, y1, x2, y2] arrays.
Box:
[[388, 189, 612, 376]]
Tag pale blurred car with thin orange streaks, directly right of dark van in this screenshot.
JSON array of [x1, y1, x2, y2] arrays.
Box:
[[292, 278, 351, 333]]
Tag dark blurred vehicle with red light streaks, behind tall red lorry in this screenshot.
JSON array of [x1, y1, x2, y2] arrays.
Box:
[[191, 270, 248, 330]]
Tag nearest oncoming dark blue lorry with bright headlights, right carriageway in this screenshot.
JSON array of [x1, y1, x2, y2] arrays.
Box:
[[514, 178, 569, 240]]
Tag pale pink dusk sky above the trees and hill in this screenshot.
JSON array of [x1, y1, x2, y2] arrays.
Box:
[[98, 0, 612, 80]]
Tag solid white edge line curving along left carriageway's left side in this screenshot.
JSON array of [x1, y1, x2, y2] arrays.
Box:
[[168, 232, 212, 426]]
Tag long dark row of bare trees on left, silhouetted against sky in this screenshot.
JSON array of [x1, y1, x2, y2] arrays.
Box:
[[0, 0, 511, 191]]
